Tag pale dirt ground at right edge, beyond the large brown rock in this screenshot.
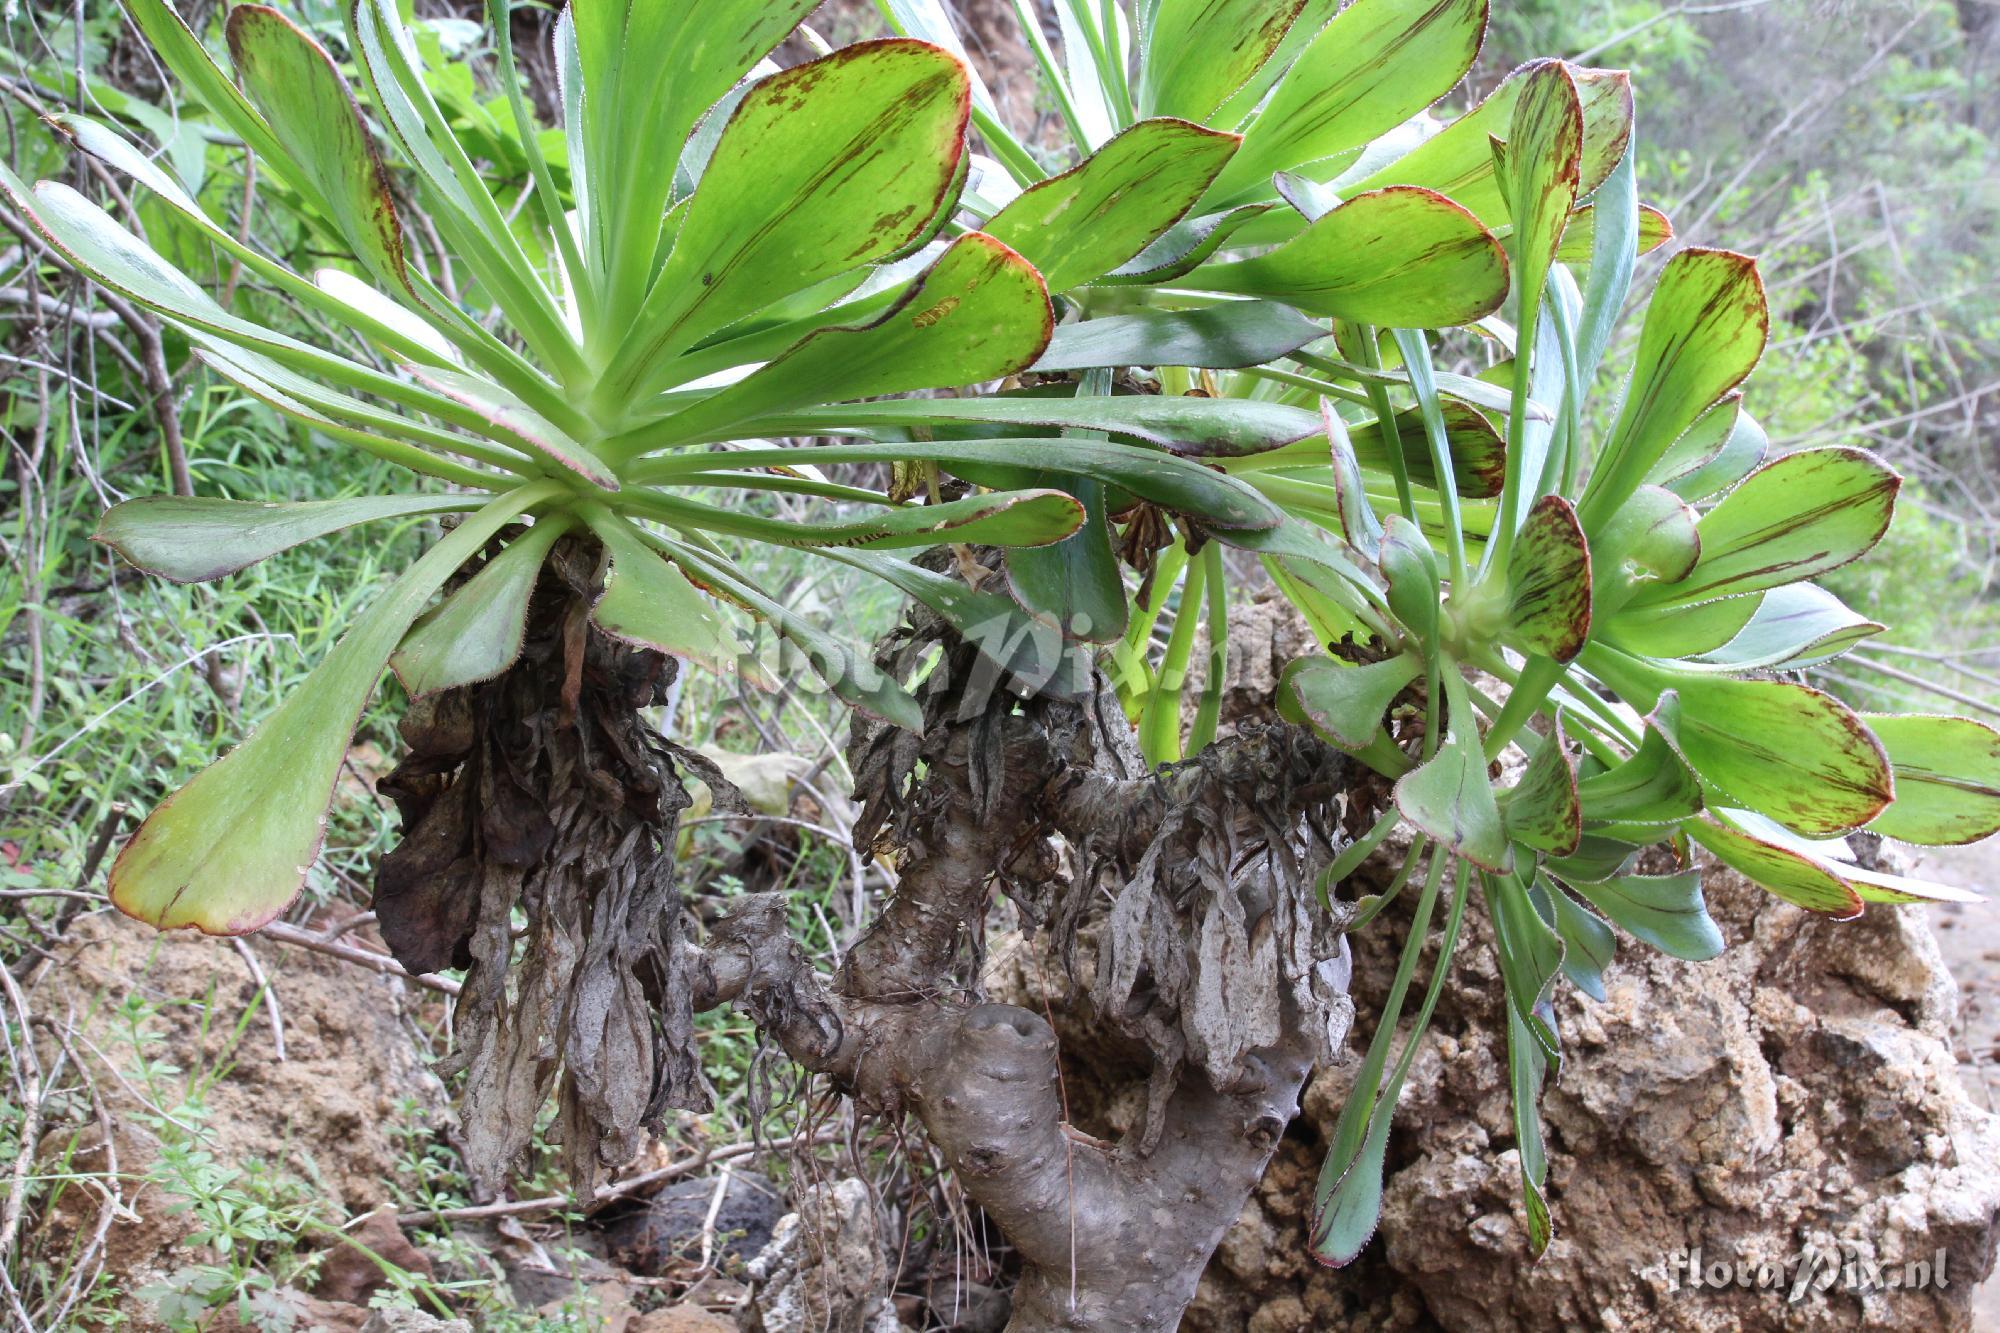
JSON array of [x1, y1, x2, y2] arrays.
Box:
[[1924, 839, 2000, 1333]]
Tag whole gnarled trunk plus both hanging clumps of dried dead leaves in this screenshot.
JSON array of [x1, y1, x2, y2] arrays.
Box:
[[376, 564, 1350, 1333]]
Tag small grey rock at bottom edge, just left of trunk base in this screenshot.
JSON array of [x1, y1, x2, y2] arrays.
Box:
[[738, 1177, 900, 1333]]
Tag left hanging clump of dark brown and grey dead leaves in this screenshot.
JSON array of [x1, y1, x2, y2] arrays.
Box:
[[374, 540, 708, 1197]]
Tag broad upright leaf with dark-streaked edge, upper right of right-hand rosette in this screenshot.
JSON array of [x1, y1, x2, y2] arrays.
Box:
[[1578, 248, 1770, 532]]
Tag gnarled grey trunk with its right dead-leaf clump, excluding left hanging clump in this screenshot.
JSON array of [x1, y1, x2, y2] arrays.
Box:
[[688, 624, 1352, 1333]]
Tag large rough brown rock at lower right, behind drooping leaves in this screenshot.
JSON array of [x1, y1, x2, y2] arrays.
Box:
[[1184, 856, 2000, 1333]]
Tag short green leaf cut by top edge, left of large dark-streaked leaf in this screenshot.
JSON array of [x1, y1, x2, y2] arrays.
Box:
[[1138, 0, 1306, 122]]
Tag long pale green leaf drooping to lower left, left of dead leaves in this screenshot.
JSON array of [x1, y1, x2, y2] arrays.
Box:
[[110, 482, 560, 935]]
